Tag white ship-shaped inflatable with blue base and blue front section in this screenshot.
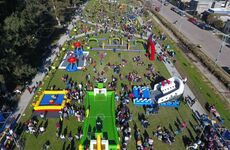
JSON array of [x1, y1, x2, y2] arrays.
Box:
[[133, 77, 184, 107]]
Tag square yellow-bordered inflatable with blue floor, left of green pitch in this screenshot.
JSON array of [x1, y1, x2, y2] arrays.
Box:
[[33, 90, 70, 112]]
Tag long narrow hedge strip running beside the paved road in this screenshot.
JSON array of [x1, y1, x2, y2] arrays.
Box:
[[149, 9, 230, 88]]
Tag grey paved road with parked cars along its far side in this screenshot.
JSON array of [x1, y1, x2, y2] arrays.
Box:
[[152, 0, 230, 67]]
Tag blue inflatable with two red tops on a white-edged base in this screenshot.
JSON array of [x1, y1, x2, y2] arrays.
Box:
[[59, 42, 89, 72]]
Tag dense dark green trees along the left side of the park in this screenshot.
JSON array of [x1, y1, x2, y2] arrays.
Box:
[[0, 0, 85, 91]]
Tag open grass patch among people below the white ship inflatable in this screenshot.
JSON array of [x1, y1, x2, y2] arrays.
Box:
[[128, 103, 197, 150]]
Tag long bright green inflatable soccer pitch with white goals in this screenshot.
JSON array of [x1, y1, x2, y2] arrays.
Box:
[[79, 83, 120, 150]]
